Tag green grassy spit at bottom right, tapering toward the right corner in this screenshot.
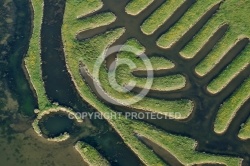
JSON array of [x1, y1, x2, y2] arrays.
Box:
[[135, 128, 242, 166]]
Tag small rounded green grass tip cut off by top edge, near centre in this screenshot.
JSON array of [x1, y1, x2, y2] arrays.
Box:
[[125, 0, 154, 15]]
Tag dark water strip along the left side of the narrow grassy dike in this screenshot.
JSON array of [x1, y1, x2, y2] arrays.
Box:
[[6, 0, 37, 116]]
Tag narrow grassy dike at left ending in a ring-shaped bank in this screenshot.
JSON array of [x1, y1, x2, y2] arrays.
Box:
[[24, 0, 82, 142]]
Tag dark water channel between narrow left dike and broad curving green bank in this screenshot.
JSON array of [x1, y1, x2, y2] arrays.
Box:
[[41, 0, 140, 165]]
